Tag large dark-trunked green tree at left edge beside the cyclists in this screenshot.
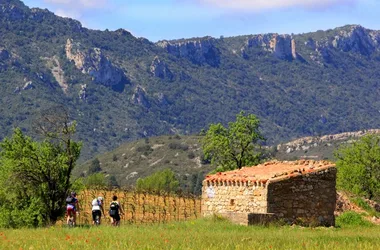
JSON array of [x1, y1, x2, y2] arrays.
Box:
[[0, 107, 81, 227]]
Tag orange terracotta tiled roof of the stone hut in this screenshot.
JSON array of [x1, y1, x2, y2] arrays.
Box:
[[205, 160, 335, 184]]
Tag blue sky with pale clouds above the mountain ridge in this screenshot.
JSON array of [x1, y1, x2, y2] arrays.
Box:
[[24, 0, 380, 41]]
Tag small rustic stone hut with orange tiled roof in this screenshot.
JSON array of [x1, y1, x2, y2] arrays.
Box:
[[202, 160, 336, 226]]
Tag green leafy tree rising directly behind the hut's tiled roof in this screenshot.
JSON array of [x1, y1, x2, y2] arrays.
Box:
[[202, 111, 265, 171]]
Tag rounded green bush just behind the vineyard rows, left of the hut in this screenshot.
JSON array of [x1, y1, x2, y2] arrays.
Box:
[[136, 169, 179, 193]]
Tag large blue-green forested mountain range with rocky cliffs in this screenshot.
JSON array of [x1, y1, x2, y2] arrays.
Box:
[[0, 0, 380, 161]]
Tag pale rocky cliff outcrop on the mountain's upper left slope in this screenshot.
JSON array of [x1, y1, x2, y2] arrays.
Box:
[[66, 39, 125, 86]]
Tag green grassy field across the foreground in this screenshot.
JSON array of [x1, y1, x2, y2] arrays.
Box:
[[0, 219, 380, 249]]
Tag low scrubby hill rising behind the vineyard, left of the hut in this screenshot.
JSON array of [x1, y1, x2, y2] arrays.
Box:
[[74, 135, 213, 190]]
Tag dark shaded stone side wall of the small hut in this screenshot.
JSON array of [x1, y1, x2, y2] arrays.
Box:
[[267, 168, 336, 226]]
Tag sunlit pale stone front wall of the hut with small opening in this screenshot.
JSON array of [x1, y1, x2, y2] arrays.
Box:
[[202, 181, 267, 216]]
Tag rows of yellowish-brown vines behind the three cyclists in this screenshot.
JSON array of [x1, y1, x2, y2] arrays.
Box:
[[72, 190, 201, 225]]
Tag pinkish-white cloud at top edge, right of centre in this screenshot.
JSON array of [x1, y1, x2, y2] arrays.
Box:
[[197, 0, 360, 11]]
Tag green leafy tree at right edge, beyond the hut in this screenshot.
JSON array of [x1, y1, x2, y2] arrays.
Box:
[[334, 134, 380, 199]]
